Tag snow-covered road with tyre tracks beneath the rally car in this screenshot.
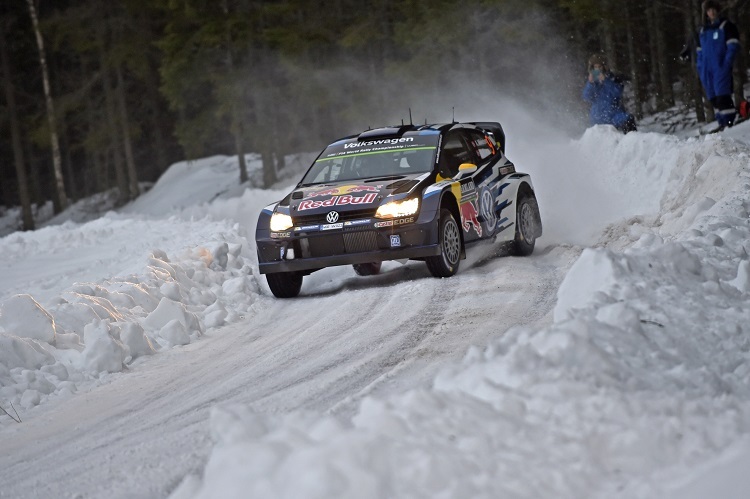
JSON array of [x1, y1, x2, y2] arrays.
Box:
[[0, 244, 579, 498]]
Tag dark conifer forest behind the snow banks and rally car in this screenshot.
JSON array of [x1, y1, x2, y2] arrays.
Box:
[[0, 0, 750, 229]]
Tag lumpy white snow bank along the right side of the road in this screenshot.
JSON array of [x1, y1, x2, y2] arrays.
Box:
[[171, 129, 750, 499]]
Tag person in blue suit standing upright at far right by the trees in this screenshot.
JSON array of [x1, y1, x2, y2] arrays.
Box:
[[696, 0, 740, 129]]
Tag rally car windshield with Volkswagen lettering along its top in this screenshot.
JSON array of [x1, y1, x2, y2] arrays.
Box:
[[301, 134, 439, 185]]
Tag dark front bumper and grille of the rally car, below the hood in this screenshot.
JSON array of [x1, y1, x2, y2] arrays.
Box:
[[256, 213, 440, 274]]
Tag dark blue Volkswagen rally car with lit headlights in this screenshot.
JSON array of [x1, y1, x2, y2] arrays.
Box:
[[255, 122, 542, 298]]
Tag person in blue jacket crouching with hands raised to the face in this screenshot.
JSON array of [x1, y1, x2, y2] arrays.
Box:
[[583, 54, 636, 133]]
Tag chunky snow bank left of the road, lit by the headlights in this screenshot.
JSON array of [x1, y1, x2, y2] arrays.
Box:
[[0, 157, 290, 414]]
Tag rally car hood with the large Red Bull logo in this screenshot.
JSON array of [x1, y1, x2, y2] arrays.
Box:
[[282, 173, 429, 217]]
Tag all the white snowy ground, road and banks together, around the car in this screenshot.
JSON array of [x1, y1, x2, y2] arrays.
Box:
[[0, 116, 750, 499]]
